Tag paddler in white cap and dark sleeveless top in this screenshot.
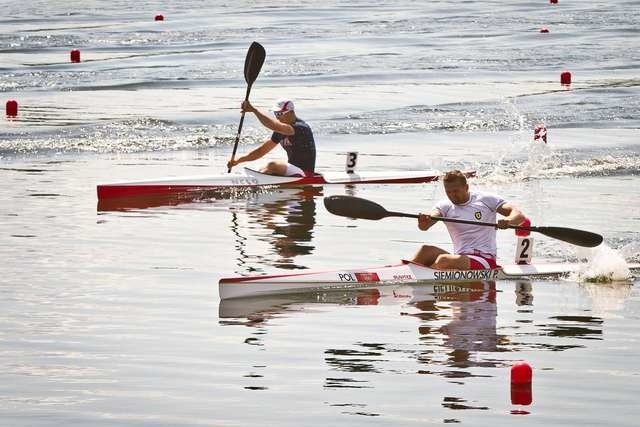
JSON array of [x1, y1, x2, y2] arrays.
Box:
[[227, 99, 316, 176]]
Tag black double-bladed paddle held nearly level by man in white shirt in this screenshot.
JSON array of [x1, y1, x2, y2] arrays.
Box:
[[324, 196, 603, 248]]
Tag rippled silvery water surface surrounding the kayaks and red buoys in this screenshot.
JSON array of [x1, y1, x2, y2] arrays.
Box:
[[0, 1, 640, 426]]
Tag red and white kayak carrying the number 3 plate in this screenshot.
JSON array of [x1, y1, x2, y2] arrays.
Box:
[[97, 168, 475, 200]]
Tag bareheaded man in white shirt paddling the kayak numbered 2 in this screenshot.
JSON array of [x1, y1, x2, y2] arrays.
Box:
[[412, 170, 525, 270]]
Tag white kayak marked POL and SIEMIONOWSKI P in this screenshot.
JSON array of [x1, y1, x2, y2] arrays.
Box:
[[218, 262, 640, 300]]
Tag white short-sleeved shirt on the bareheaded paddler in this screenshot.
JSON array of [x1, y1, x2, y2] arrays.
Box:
[[435, 191, 505, 258]]
